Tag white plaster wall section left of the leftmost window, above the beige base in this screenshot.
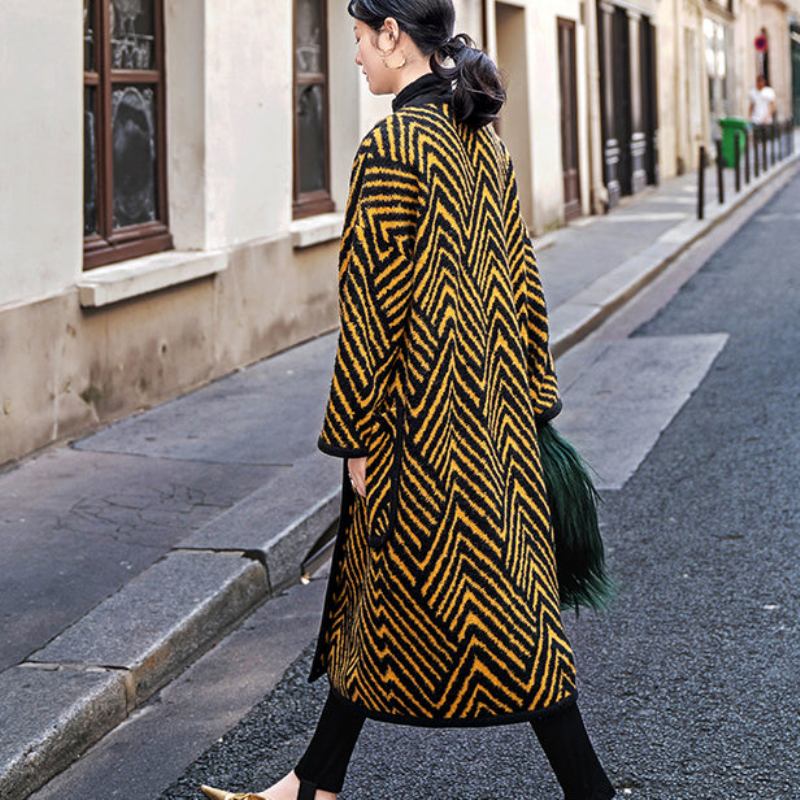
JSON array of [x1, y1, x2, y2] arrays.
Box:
[[0, 0, 83, 306]]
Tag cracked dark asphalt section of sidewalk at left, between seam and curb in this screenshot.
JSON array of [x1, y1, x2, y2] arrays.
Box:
[[0, 447, 275, 671]]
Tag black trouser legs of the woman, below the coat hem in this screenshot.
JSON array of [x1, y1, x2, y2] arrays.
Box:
[[294, 687, 616, 800]]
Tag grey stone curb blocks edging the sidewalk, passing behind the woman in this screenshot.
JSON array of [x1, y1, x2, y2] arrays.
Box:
[[0, 147, 800, 800]]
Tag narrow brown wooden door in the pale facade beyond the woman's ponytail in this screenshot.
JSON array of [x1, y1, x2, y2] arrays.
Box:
[[557, 17, 581, 220]]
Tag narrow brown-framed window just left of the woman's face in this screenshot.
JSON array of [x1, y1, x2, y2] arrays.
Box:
[[293, 0, 334, 218]]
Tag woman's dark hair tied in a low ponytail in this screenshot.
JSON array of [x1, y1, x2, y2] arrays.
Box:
[[347, 0, 506, 128]]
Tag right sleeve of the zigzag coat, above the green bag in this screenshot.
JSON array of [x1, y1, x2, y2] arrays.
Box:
[[502, 144, 562, 422]]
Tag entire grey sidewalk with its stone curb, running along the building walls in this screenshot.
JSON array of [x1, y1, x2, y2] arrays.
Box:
[[0, 135, 800, 800]]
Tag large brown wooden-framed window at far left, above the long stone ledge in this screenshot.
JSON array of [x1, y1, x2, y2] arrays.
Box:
[[83, 0, 172, 269]]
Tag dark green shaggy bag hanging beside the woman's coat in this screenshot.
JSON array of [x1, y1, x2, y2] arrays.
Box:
[[536, 419, 617, 617]]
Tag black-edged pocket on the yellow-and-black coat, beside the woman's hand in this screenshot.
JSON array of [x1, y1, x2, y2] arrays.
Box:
[[364, 396, 404, 549]]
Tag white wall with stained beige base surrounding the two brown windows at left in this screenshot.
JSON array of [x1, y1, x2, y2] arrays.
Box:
[[0, 0, 480, 464]]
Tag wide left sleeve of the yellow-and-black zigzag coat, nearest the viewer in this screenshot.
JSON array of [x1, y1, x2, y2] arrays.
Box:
[[317, 116, 423, 458]]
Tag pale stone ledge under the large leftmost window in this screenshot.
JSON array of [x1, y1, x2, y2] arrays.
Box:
[[77, 250, 228, 308]]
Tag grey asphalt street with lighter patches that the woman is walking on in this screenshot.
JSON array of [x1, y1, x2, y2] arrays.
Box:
[[34, 164, 800, 800]]
